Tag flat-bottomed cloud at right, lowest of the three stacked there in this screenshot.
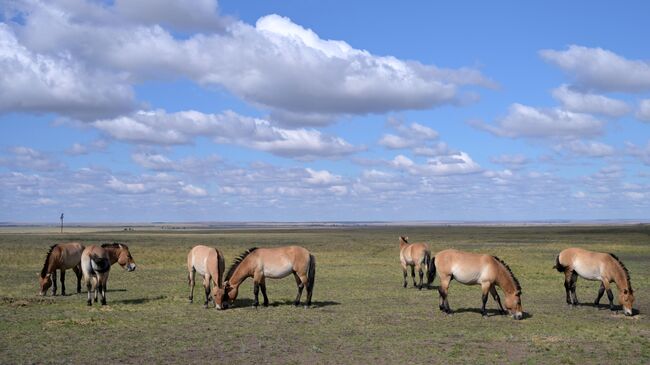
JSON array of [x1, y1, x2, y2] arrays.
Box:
[[472, 103, 605, 139]]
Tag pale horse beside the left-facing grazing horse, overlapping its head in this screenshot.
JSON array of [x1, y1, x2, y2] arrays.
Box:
[[187, 245, 226, 309]]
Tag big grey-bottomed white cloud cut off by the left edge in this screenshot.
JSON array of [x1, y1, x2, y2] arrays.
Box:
[[0, 23, 135, 119]]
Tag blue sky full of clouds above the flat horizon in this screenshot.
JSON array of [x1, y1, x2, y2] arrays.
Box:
[[0, 0, 650, 223]]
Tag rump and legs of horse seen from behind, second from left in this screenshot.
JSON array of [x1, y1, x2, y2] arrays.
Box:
[[81, 245, 111, 305]]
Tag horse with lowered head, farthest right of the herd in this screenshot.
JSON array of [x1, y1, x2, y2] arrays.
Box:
[[553, 247, 634, 316]]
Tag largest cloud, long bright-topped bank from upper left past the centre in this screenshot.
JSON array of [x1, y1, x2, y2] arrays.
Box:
[[5, 0, 493, 126]]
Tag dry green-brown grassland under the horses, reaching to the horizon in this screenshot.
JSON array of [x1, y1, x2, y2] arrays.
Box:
[[0, 225, 650, 364]]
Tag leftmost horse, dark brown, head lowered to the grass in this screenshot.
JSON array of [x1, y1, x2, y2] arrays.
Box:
[[38, 242, 84, 295]]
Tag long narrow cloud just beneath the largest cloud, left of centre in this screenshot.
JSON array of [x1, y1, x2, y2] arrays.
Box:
[[93, 110, 360, 162]]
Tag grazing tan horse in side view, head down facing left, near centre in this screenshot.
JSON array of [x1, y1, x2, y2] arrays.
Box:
[[225, 246, 316, 308]]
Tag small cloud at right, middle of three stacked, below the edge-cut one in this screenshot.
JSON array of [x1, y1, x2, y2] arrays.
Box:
[[553, 85, 630, 118]]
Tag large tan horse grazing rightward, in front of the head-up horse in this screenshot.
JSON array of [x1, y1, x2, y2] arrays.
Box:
[[431, 249, 523, 320]]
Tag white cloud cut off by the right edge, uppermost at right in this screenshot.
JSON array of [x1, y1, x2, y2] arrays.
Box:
[[539, 45, 650, 92]]
